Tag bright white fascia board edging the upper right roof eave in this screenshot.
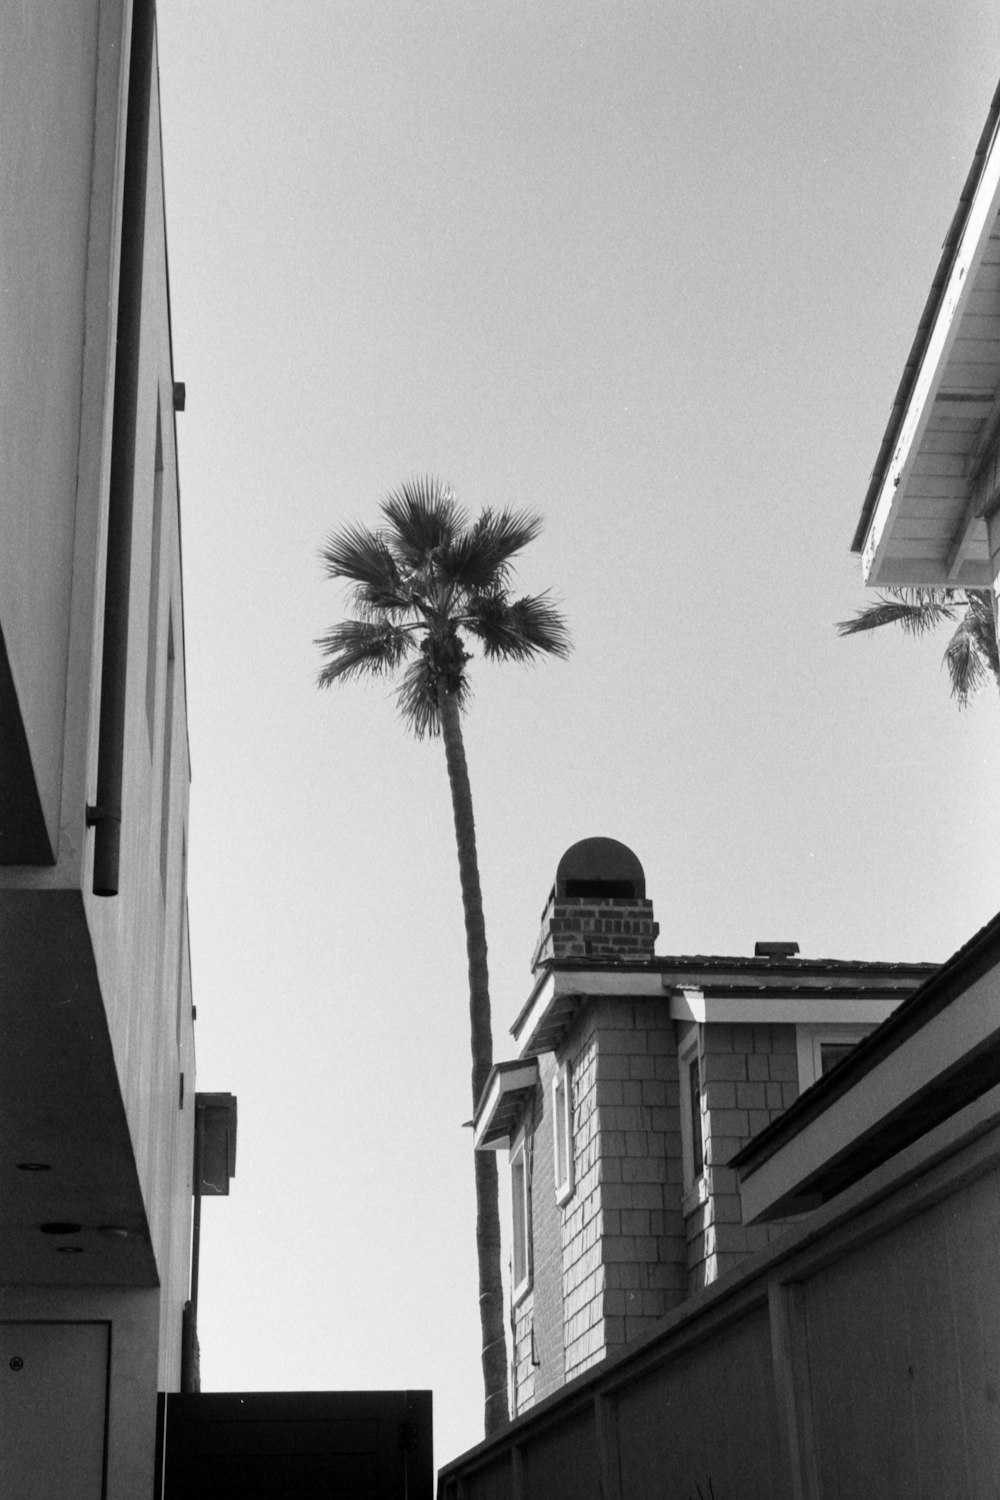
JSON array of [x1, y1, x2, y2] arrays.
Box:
[[862, 135, 1000, 587]]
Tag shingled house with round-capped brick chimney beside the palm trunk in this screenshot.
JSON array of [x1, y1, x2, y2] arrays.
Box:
[[474, 839, 934, 1413]]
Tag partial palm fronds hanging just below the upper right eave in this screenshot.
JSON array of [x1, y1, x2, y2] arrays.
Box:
[[837, 588, 1000, 708]]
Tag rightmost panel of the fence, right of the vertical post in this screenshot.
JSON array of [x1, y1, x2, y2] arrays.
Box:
[[805, 1173, 1000, 1500]]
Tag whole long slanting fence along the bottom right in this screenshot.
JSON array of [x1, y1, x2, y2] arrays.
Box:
[[438, 1091, 1000, 1500]]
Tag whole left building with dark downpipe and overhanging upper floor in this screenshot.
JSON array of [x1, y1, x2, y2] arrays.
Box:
[[0, 0, 234, 1497]]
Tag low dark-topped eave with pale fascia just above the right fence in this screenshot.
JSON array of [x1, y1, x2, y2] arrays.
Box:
[[730, 917, 1000, 1223]]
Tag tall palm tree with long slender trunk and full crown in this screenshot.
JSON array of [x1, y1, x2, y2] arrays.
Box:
[[316, 479, 570, 1437]]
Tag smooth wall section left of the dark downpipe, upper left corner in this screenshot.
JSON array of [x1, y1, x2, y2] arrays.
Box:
[[0, 0, 110, 845]]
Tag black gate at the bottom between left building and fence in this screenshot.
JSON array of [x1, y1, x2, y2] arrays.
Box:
[[157, 1391, 433, 1500]]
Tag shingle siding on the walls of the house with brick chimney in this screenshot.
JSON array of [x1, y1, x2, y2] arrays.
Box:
[[513, 998, 815, 1412]]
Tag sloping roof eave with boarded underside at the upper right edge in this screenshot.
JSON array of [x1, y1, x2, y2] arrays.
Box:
[[852, 79, 1000, 588]]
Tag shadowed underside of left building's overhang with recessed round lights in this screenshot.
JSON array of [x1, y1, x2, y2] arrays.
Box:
[[0, 890, 159, 1287]]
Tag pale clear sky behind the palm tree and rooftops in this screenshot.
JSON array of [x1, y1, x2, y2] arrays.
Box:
[[157, 0, 1000, 1463]]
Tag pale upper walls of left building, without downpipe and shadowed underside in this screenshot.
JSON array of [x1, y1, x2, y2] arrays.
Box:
[[0, 0, 195, 1389]]
